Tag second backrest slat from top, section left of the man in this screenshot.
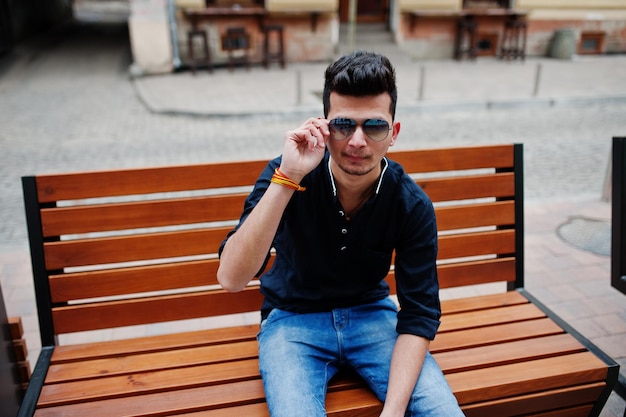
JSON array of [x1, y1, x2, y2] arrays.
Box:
[[41, 194, 247, 237]]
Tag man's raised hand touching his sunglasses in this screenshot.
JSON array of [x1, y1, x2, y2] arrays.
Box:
[[280, 118, 330, 182]]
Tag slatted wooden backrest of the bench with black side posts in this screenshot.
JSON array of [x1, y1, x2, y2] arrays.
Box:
[[22, 145, 524, 346]]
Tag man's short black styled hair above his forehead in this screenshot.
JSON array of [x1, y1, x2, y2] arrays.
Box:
[[323, 51, 398, 118]]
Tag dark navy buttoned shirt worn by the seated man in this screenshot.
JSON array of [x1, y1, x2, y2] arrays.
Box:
[[222, 153, 441, 340]]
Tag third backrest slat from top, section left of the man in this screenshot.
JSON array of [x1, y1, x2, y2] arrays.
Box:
[[44, 227, 232, 271]]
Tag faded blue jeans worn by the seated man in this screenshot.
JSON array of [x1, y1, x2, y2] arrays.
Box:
[[258, 299, 463, 417]]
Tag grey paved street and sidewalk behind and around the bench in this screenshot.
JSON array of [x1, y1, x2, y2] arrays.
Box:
[[0, 18, 626, 417]]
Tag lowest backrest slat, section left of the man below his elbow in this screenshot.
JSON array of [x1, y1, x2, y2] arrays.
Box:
[[52, 287, 263, 333]]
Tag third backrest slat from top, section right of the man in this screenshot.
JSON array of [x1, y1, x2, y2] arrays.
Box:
[[436, 201, 515, 232]]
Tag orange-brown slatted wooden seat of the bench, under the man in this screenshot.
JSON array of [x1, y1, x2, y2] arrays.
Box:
[[25, 291, 608, 416]]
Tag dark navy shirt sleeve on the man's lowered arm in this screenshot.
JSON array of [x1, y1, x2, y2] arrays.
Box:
[[395, 190, 441, 340]]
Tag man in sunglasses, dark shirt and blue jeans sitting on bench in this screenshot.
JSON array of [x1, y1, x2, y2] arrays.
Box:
[[218, 52, 463, 417]]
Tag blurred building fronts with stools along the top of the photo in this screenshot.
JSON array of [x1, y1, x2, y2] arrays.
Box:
[[0, 0, 626, 73]]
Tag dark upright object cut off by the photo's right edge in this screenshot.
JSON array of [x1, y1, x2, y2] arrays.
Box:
[[611, 137, 626, 294]]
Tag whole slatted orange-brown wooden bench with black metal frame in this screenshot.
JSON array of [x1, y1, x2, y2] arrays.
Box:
[[19, 145, 619, 417]]
